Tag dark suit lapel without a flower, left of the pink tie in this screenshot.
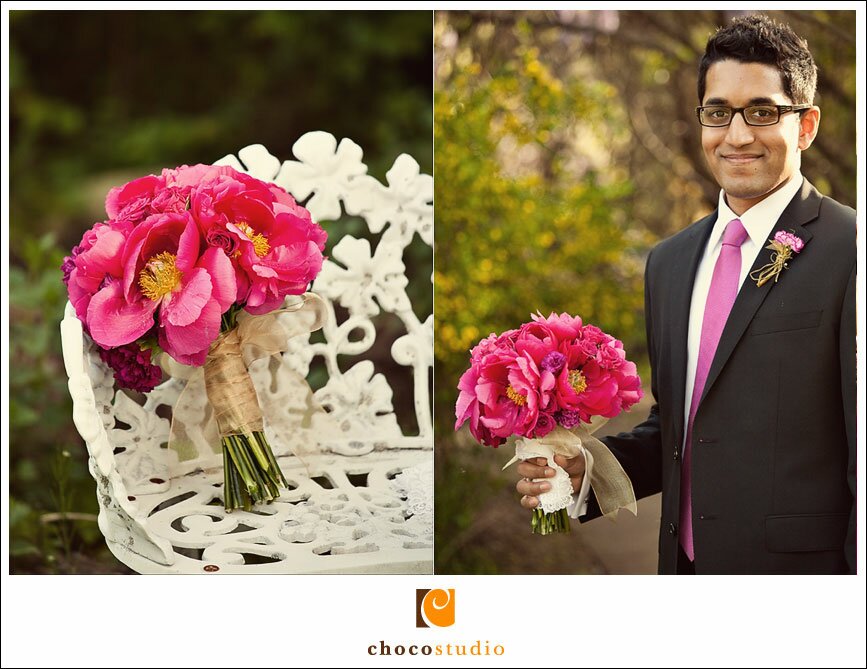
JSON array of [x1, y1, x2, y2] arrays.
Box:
[[669, 211, 717, 449]]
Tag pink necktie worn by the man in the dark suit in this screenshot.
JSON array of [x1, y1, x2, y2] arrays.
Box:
[[680, 218, 748, 561]]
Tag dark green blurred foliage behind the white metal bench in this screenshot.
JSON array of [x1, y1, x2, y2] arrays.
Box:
[[7, 11, 433, 573]]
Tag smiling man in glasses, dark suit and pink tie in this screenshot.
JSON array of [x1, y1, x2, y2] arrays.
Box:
[[517, 16, 857, 574]]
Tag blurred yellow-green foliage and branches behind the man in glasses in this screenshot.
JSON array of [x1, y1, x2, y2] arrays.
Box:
[[434, 10, 856, 573]]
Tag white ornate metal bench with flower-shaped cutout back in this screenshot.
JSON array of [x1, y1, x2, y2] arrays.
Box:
[[61, 132, 433, 573]]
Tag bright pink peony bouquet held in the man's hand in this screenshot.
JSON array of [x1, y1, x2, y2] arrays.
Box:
[[455, 313, 642, 534]]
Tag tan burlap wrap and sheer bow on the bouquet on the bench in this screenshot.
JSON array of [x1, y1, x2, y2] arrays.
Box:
[[161, 293, 327, 461]]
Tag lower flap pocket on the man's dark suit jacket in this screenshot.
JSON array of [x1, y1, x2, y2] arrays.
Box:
[[765, 513, 849, 553]]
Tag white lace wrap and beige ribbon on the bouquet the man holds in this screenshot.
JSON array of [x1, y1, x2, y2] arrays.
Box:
[[503, 417, 638, 520]]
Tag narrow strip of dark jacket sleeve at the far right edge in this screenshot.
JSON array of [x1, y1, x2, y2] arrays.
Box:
[[840, 258, 858, 574]]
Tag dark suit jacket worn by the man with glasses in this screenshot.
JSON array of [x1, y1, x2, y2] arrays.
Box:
[[586, 180, 856, 574]]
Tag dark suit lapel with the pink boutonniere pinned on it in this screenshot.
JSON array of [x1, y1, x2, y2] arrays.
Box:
[[693, 179, 821, 404]]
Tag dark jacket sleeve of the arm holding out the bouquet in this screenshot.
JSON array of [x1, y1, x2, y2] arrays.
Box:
[[580, 252, 662, 522]]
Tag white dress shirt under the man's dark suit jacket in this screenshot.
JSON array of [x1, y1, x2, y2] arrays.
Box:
[[567, 172, 804, 518]]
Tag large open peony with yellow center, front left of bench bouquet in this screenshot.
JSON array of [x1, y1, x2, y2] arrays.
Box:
[[87, 212, 236, 365]]
